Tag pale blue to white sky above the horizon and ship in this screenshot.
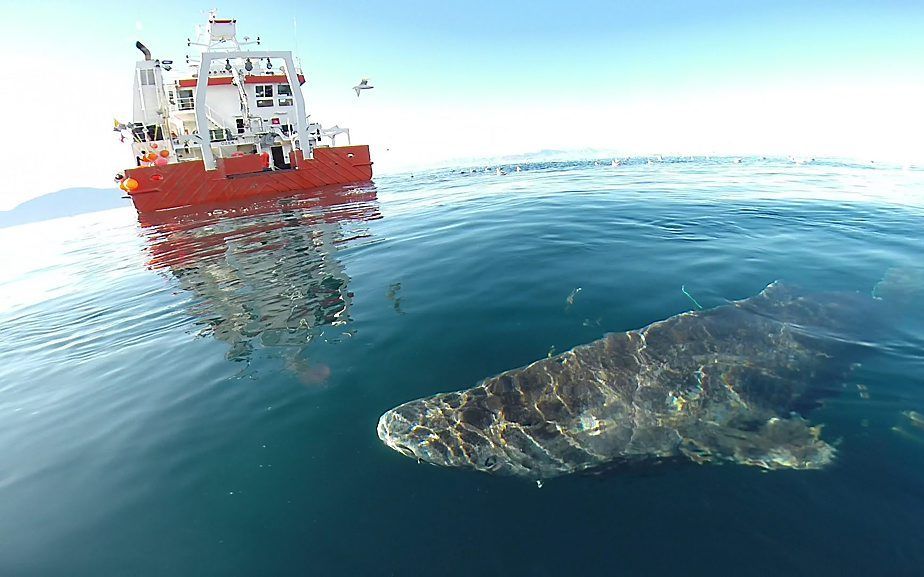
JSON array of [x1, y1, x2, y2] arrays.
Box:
[[0, 0, 924, 210]]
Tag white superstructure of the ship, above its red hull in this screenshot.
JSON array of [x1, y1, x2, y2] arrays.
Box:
[[122, 12, 349, 170]]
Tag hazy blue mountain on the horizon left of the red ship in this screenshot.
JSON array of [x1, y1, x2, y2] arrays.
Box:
[[0, 188, 131, 228]]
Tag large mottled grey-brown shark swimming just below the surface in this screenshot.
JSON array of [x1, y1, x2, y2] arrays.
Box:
[[377, 282, 877, 480]]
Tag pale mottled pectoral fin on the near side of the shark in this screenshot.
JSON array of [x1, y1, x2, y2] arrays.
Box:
[[680, 415, 836, 469]]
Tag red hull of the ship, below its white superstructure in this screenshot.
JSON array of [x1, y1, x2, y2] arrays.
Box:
[[125, 145, 372, 212]]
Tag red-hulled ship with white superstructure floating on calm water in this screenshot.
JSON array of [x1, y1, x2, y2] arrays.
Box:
[[114, 13, 372, 212]]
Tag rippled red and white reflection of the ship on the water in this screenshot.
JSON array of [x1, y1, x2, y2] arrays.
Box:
[[138, 184, 381, 374]]
